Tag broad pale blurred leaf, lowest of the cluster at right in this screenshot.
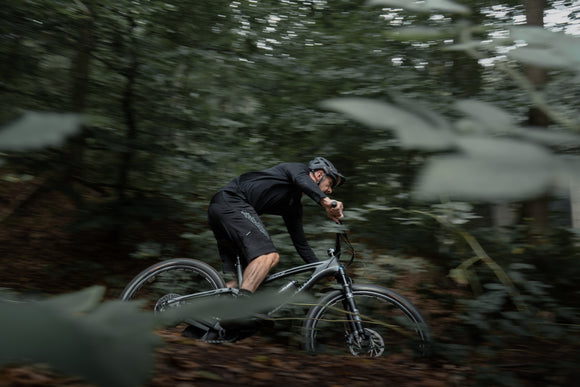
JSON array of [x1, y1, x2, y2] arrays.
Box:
[[415, 136, 561, 201]]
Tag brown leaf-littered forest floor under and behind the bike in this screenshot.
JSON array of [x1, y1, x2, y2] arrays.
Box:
[[0, 180, 573, 387]]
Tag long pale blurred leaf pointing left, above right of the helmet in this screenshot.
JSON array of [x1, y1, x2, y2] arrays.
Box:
[[322, 98, 454, 151]]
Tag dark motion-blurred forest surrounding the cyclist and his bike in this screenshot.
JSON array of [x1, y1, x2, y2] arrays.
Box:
[[0, 0, 580, 386]]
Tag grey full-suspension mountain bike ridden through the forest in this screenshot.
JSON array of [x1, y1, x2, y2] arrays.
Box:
[[121, 220, 431, 357]]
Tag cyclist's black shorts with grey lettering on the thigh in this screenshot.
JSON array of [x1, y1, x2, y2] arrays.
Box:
[[208, 191, 277, 272]]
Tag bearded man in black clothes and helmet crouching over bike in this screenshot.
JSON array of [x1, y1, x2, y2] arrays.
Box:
[[208, 157, 345, 294]]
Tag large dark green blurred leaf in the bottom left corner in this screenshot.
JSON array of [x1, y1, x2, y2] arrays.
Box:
[[0, 287, 160, 387]]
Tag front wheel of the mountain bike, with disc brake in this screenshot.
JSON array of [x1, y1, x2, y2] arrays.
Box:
[[303, 285, 431, 357]]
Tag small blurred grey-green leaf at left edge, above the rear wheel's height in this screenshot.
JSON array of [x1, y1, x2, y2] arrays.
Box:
[[0, 112, 82, 151]]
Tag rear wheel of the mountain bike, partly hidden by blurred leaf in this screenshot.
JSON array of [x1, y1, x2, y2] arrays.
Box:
[[120, 258, 226, 311]]
